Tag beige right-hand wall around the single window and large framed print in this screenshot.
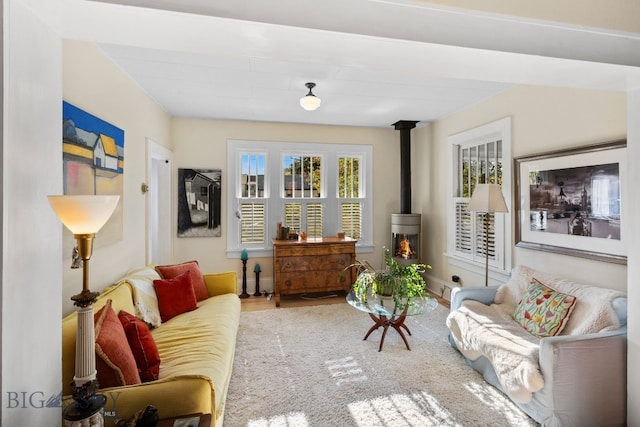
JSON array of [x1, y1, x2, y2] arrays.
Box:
[[414, 86, 627, 291]]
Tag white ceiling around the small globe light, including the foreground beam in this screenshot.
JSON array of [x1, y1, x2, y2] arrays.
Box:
[[23, 0, 640, 127]]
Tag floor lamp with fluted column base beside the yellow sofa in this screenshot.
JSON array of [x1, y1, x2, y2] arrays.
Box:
[[48, 196, 120, 427]]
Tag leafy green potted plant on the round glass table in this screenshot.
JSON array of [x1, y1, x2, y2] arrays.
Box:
[[347, 248, 431, 310]]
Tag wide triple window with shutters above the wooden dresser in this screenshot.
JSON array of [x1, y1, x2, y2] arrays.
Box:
[[227, 140, 373, 256]]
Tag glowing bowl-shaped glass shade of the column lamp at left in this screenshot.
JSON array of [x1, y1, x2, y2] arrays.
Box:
[[48, 196, 120, 234]]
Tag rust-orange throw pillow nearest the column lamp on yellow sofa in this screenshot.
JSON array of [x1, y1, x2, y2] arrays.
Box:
[[93, 300, 141, 388]]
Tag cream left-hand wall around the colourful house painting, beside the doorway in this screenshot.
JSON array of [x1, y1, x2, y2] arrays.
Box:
[[62, 40, 171, 313]]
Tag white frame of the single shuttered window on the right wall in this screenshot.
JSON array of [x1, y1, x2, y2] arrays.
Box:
[[446, 117, 513, 281]]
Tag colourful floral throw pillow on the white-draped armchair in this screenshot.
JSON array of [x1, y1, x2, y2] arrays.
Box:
[[513, 279, 576, 338]]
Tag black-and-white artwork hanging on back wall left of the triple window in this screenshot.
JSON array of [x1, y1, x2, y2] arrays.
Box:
[[178, 168, 222, 237]]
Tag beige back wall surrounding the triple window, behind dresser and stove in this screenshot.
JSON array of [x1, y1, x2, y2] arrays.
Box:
[[171, 118, 400, 290]]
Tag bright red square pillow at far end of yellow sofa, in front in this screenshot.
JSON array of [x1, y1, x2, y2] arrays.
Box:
[[153, 271, 198, 322]]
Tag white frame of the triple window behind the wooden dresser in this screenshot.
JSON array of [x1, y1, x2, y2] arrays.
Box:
[[226, 139, 373, 258]]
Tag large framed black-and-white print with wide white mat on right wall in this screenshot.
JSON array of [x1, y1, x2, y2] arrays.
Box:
[[514, 140, 628, 264]]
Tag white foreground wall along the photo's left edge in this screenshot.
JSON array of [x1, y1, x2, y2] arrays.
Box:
[[0, 0, 62, 426]]
